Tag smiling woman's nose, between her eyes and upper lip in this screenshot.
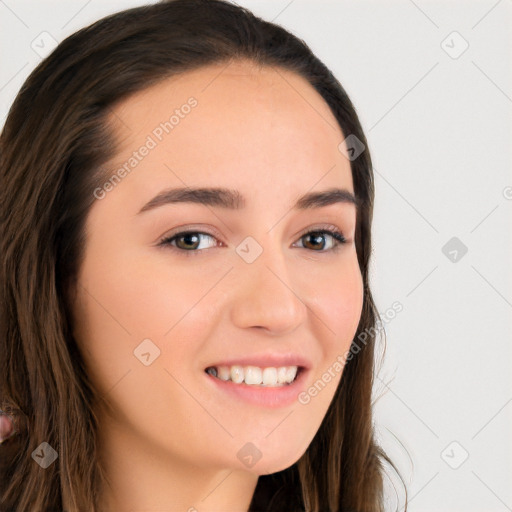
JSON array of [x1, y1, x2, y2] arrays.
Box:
[[231, 245, 307, 335]]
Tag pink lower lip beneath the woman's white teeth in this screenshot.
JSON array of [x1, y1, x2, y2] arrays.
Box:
[[205, 368, 309, 409]]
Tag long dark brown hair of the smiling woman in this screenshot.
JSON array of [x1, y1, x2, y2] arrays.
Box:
[[0, 0, 405, 512]]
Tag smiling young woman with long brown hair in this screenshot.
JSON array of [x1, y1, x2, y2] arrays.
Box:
[[0, 0, 408, 512]]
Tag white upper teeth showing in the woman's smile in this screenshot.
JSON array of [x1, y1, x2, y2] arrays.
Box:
[[207, 365, 297, 386]]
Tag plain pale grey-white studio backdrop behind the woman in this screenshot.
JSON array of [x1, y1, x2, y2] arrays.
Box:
[[0, 0, 512, 512]]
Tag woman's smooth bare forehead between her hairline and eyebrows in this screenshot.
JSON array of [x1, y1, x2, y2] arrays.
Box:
[[102, 61, 352, 208]]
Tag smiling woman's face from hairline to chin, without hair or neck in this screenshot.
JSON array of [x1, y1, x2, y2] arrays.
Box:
[[73, 62, 363, 474]]
